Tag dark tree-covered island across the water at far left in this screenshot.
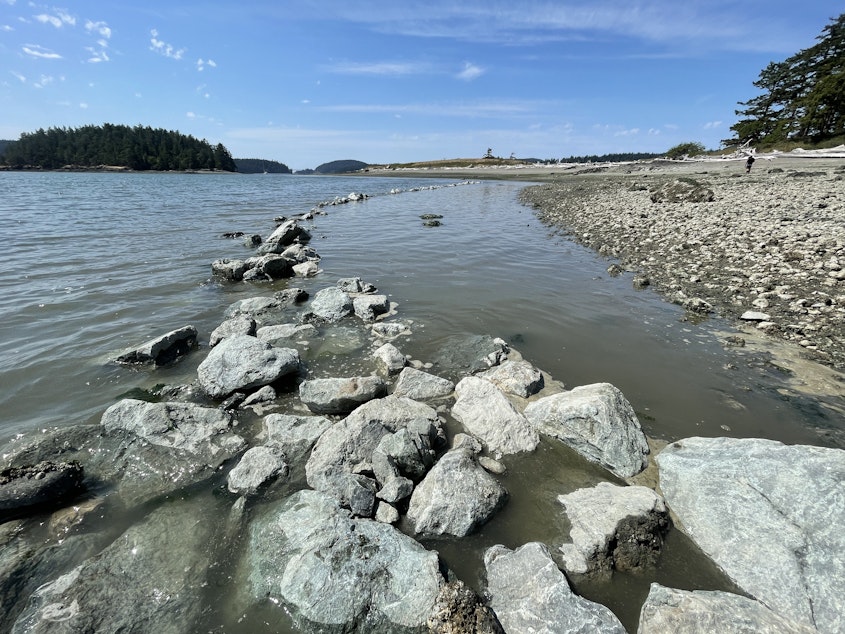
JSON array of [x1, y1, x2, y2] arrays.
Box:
[[2, 123, 237, 172]]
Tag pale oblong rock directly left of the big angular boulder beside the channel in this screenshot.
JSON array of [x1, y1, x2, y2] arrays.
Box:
[[452, 376, 540, 454]]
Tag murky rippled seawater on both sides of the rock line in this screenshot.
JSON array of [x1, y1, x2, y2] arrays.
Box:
[[0, 173, 842, 631]]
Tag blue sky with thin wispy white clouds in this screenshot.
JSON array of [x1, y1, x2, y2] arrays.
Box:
[[0, 0, 843, 169]]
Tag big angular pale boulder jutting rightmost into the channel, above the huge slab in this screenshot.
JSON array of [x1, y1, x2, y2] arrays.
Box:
[[524, 383, 649, 478]]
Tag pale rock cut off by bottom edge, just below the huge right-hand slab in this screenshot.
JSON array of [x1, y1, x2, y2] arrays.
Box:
[[637, 583, 818, 634]]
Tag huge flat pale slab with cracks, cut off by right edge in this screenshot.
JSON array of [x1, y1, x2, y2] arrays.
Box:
[[657, 438, 845, 632]]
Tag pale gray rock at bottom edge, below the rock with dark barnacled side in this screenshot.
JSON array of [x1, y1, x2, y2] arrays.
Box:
[[484, 542, 625, 634]]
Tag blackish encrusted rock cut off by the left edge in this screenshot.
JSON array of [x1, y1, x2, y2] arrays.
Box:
[[0, 460, 84, 522]]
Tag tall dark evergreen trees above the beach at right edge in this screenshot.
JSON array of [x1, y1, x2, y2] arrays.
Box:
[[722, 13, 845, 147]]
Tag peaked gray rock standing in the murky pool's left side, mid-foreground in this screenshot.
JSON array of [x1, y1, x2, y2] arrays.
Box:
[[407, 442, 508, 537]]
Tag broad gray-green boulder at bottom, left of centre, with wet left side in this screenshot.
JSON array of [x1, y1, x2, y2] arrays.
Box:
[[247, 490, 444, 633]]
